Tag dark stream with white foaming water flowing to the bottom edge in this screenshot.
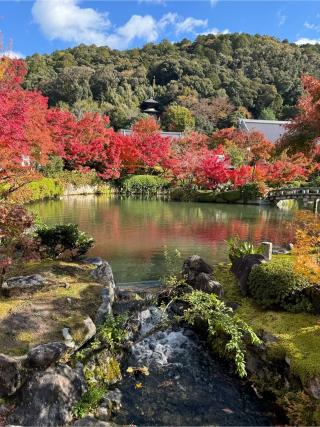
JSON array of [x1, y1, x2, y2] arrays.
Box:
[[114, 307, 272, 426]]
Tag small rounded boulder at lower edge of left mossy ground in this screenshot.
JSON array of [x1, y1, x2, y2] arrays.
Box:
[[27, 342, 67, 369]]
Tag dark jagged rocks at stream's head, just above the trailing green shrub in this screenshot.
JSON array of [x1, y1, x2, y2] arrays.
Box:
[[182, 255, 223, 297]]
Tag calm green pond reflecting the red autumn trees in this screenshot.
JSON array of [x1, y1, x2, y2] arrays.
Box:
[[30, 196, 292, 282]]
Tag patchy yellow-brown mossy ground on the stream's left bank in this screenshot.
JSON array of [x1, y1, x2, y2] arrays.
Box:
[[0, 261, 102, 355]]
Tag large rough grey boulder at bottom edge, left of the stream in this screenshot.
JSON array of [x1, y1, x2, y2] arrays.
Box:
[[9, 365, 86, 427]]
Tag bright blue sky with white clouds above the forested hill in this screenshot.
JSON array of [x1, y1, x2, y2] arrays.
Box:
[[0, 0, 320, 56]]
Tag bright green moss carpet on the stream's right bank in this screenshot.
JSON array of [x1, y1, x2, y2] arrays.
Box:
[[215, 257, 320, 383]]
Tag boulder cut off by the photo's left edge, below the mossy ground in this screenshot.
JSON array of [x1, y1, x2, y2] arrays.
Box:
[[0, 354, 25, 397]]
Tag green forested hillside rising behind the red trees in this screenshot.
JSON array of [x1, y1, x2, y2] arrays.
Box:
[[25, 34, 320, 133]]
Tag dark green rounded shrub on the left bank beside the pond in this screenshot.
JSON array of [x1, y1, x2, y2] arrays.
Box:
[[35, 224, 94, 258]]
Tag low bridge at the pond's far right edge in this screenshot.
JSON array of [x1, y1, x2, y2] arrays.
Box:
[[266, 187, 320, 212]]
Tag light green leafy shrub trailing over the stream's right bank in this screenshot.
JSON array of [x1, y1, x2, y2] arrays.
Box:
[[184, 291, 260, 377]]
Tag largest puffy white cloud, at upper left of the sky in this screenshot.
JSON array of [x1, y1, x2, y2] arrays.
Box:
[[32, 0, 111, 45]]
